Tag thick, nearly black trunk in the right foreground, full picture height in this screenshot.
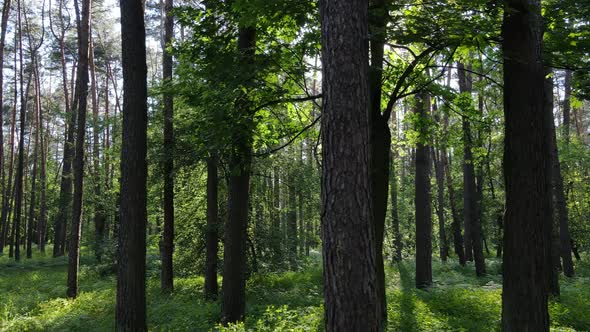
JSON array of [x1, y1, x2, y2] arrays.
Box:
[[502, 0, 552, 331]]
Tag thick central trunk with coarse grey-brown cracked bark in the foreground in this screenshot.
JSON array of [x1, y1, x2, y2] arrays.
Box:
[[320, 0, 381, 332]]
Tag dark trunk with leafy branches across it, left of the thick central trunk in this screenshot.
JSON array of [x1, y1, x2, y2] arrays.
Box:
[[221, 27, 256, 324]]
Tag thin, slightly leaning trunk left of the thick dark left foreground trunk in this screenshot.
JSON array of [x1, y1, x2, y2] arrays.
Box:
[[66, 0, 90, 298]]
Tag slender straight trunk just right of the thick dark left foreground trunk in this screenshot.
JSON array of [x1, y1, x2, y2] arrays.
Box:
[[161, 0, 174, 292]]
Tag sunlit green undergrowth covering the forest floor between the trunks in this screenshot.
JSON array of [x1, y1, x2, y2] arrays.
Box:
[[0, 253, 590, 331]]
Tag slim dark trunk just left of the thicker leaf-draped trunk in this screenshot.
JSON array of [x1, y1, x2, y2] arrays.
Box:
[[205, 156, 219, 300]]
